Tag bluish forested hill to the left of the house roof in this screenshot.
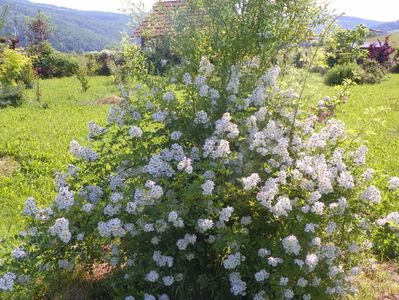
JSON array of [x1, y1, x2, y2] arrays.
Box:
[[0, 0, 130, 52]]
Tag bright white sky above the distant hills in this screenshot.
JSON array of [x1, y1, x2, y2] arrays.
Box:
[[30, 0, 399, 21]]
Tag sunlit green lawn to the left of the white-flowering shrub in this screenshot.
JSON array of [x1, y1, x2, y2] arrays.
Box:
[[0, 77, 117, 246]]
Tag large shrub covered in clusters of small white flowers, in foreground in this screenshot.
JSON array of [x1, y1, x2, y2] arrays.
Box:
[[0, 59, 398, 299]]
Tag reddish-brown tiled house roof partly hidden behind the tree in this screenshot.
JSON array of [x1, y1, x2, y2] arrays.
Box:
[[133, 0, 186, 38]]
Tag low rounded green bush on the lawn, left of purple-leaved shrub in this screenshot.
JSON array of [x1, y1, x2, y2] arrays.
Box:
[[324, 63, 364, 85]]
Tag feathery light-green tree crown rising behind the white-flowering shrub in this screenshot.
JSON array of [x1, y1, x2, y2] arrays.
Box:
[[173, 0, 323, 84]]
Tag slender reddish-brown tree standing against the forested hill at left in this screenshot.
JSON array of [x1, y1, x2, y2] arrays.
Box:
[[25, 11, 54, 54]]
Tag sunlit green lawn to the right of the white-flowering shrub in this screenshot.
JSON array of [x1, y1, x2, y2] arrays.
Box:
[[306, 74, 399, 175]]
